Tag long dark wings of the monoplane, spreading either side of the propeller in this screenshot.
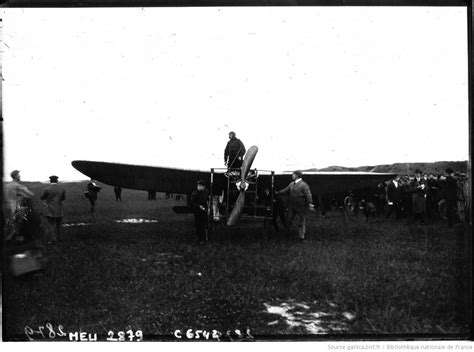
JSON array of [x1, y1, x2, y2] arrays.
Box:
[[72, 160, 396, 195]]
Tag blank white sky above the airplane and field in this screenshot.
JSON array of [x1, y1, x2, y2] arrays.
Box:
[[0, 7, 469, 180]]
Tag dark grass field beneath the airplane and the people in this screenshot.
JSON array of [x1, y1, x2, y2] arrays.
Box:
[[3, 183, 470, 340]]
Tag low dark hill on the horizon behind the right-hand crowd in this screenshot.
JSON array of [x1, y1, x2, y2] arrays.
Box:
[[304, 160, 467, 175]]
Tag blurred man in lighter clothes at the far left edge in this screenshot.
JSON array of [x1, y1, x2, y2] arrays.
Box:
[[5, 170, 34, 241]]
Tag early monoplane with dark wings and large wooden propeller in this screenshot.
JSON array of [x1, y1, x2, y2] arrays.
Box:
[[72, 146, 395, 226]]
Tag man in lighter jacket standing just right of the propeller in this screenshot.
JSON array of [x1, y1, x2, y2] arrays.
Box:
[[277, 171, 314, 241]]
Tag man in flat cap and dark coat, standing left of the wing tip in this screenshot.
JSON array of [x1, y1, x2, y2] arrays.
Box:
[[40, 176, 66, 242]]
